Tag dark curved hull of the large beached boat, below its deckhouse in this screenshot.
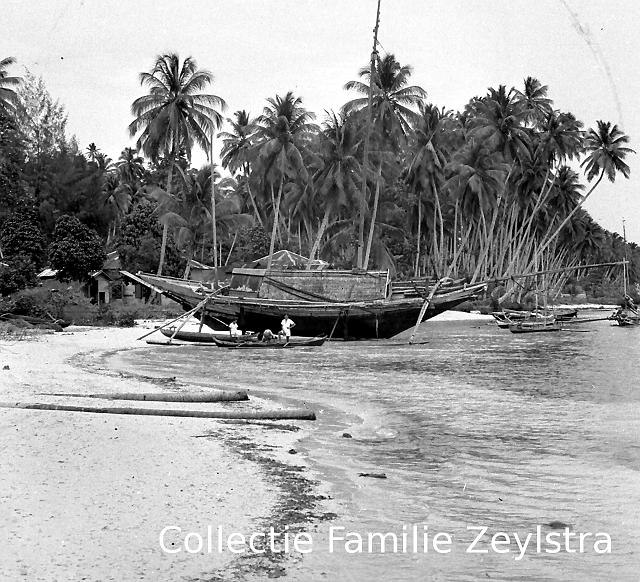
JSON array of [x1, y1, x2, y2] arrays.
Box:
[[137, 273, 484, 339]]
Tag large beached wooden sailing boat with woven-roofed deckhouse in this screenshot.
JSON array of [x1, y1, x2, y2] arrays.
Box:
[[132, 268, 485, 339]]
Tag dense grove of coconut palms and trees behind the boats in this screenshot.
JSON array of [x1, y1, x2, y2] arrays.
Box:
[[0, 53, 640, 301]]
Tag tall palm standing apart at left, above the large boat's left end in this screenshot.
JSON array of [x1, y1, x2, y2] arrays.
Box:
[[129, 53, 225, 275]]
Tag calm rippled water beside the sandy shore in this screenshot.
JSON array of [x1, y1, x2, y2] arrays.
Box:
[[111, 320, 640, 581]]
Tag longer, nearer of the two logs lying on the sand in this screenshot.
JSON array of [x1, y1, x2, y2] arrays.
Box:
[[0, 402, 316, 420]]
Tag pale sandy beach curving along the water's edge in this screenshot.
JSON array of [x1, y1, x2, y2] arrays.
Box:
[[0, 323, 318, 582]]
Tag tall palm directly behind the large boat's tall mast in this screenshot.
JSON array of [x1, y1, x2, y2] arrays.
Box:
[[344, 54, 427, 269]]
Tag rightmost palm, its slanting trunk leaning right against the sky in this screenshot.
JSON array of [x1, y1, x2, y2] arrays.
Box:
[[538, 121, 636, 254]]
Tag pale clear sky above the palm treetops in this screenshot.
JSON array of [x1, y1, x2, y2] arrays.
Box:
[[5, 0, 640, 243]]
